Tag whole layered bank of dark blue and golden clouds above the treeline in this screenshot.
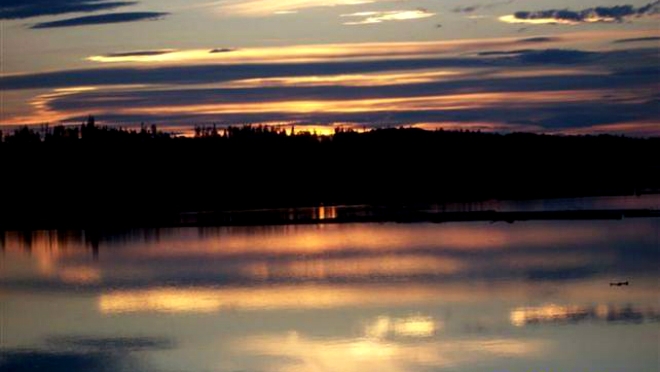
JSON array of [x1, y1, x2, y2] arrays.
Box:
[[2, 31, 658, 137]]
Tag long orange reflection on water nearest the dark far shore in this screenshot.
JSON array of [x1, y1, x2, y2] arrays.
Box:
[[132, 221, 624, 257]]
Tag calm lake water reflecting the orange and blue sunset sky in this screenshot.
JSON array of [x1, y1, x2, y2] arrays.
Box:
[[0, 199, 660, 372]]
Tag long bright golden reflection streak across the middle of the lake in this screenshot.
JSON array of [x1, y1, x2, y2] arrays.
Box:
[[98, 285, 460, 314]]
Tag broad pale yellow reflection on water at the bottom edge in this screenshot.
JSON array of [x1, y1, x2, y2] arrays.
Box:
[[234, 331, 544, 372]]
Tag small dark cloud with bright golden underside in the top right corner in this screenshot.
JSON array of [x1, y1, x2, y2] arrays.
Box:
[[500, 0, 660, 25]]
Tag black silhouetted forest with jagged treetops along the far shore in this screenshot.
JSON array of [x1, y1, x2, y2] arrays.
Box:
[[0, 117, 660, 229]]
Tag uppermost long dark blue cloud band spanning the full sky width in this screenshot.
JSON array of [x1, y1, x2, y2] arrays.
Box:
[[2, 48, 657, 91]]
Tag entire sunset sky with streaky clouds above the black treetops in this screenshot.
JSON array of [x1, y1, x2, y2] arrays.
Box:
[[0, 0, 660, 136]]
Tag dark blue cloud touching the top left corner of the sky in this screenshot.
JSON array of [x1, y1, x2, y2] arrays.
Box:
[[0, 0, 137, 19]]
